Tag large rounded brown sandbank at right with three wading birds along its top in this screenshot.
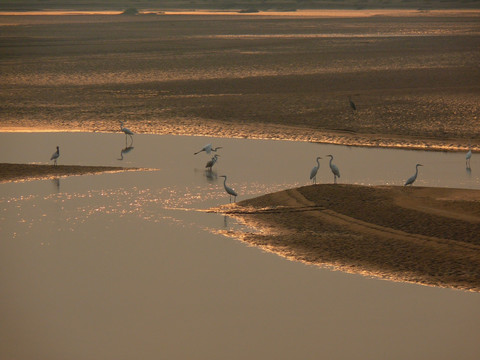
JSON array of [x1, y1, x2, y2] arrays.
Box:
[[216, 185, 480, 291]]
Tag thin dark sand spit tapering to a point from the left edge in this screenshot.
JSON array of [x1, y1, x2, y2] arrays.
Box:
[[0, 163, 142, 183]]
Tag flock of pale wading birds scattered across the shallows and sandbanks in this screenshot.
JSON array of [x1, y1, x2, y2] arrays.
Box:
[[50, 118, 472, 202]]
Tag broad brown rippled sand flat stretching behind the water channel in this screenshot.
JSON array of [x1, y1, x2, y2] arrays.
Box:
[[0, 11, 480, 150]]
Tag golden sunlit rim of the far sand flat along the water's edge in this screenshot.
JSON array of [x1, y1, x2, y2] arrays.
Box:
[[0, 119, 480, 152]]
